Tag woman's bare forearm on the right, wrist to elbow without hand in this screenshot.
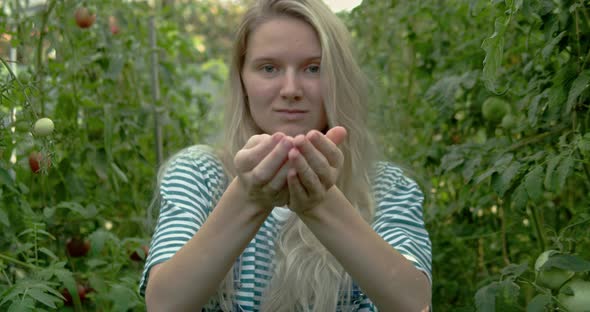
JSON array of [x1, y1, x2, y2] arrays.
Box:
[[299, 187, 431, 311]]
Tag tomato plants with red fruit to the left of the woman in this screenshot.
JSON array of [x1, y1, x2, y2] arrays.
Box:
[[0, 0, 241, 311]]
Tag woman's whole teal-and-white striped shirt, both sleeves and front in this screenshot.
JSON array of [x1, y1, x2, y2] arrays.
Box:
[[139, 145, 432, 311]]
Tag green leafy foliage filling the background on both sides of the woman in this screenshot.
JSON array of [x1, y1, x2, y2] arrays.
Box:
[[0, 0, 590, 311]]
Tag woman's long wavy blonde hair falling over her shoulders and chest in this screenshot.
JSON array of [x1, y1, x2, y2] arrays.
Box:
[[218, 0, 374, 312]]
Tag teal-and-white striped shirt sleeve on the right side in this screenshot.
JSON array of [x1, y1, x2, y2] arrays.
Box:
[[373, 163, 432, 285]]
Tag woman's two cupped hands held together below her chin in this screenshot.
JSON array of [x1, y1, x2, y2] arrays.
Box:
[[234, 126, 347, 213]]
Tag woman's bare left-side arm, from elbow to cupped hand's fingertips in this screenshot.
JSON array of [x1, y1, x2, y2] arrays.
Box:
[[146, 133, 292, 311]]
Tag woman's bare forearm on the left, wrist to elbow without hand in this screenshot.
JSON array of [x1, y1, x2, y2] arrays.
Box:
[[146, 179, 270, 311]]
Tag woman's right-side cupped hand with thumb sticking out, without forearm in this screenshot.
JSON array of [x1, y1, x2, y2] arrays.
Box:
[[287, 127, 346, 213]]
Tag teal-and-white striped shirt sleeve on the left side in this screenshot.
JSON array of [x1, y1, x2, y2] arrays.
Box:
[[139, 145, 226, 296]]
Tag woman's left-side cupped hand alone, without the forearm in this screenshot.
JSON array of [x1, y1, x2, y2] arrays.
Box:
[[234, 132, 293, 209]]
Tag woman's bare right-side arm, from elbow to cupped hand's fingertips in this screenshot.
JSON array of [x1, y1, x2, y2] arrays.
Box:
[[287, 127, 431, 311]]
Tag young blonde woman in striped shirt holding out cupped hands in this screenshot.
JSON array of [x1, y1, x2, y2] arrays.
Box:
[[140, 0, 431, 312]]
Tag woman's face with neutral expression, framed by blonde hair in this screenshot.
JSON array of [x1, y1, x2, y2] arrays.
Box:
[[242, 17, 327, 136]]
